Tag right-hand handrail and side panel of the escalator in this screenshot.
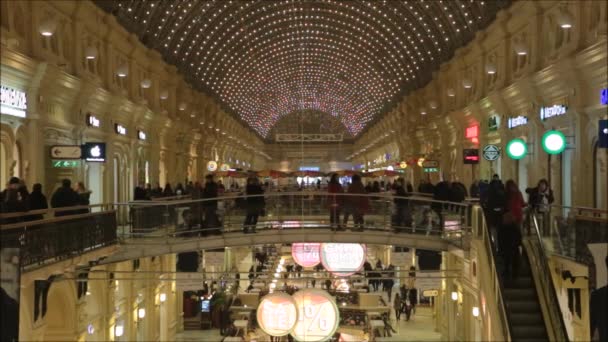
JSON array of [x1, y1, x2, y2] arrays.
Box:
[[524, 212, 569, 341]]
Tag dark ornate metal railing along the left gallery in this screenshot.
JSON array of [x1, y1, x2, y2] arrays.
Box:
[[0, 205, 117, 268]]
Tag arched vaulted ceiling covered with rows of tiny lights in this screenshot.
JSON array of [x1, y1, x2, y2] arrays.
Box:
[[95, 0, 510, 138]]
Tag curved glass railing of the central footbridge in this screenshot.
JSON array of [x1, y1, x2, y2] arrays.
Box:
[[116, 191, 471, 246]]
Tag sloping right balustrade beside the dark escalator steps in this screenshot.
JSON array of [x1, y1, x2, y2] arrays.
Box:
[[523, 213, 569, 341]]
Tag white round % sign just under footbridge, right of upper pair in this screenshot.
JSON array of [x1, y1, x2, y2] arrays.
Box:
[[321, 243, 365, 277]]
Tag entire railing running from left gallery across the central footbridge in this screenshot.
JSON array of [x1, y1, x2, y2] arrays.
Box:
[[0, 191, 471, 267]]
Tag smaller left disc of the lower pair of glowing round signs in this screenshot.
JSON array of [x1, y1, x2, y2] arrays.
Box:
[[257, 293, 298, 336]]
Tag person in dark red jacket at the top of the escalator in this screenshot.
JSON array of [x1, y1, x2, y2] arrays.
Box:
[[498, 179, 526, 280]]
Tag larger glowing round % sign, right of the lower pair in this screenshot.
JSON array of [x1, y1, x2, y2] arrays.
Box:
[[291, 289, 340, 342]]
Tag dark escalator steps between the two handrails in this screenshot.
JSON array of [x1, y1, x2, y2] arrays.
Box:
[[503, 253, 549, 342]]
